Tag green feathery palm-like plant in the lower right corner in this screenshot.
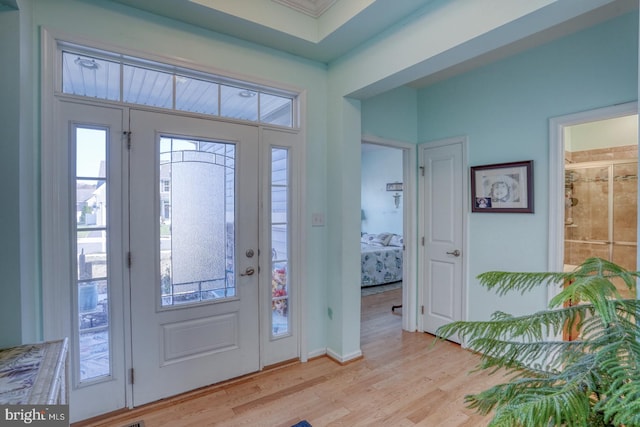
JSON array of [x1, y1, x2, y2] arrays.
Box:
[[436, 258, 640, 427]]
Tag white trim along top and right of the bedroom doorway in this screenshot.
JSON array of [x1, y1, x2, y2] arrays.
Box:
[[361, 135, 418, 332]]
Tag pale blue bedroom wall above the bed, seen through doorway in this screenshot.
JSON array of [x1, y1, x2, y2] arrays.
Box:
[[361, 147, 404, 235]]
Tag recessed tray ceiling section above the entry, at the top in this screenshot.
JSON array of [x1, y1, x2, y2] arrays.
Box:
[[111, 0, 434, 63]]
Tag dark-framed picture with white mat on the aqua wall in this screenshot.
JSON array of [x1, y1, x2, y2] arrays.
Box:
[[471, 160, 533, 213]]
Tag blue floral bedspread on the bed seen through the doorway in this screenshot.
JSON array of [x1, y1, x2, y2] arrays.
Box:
[[360, 243, 402, 287]]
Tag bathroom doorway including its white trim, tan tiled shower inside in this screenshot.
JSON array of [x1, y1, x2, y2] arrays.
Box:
[[548, 102, 638, 340]]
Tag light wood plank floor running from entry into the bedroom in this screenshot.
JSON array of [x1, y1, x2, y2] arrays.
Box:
[[73, 289, 504, 427]]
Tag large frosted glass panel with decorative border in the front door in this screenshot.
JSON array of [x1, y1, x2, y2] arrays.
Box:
[[160, 137, 235, 306]]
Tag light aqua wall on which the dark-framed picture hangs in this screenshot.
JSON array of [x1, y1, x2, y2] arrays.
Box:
[[418, 13, 638, 319]]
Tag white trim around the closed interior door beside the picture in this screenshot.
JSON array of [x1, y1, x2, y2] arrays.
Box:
[[417, 136, 469, 332]]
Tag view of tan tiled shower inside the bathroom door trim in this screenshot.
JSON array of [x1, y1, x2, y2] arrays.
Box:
[[564, 114, 638, 339]]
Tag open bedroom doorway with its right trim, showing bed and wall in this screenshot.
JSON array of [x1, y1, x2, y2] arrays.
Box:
[[360, 139, 415, 330]]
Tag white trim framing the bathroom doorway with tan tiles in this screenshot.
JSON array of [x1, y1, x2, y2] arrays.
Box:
[[547, 102, 638, 301]]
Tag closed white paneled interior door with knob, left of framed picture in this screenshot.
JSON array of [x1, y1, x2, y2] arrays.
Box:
[[421, 142, 464, 341]]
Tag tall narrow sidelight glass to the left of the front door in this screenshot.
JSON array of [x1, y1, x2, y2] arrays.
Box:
[[74, 126, 111, 382]]
